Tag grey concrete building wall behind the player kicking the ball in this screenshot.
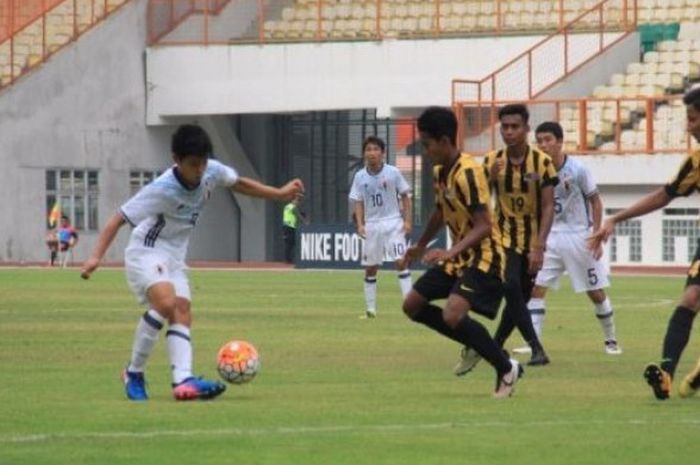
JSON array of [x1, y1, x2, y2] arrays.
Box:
[[0, 0, 266, 262]]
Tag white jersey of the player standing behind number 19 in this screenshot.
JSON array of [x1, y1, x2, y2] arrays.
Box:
[[552, 156, 598, 232]]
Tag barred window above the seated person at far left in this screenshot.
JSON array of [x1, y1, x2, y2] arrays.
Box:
[[46, 170, 99, 231]]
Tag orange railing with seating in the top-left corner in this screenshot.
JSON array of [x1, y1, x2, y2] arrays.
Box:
[[0, 0, 129, 89]]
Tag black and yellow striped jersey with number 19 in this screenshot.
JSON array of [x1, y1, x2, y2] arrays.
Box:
[[484, 146, 559, 254]]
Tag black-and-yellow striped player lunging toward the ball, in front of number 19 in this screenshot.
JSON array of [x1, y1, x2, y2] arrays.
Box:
[[403, 107, 522, 398]]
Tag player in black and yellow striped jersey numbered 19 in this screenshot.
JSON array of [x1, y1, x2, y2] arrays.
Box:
[[484, 104, 558, 365]]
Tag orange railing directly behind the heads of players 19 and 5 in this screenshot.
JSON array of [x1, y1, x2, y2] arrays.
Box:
[[455, 95, 696, 155]]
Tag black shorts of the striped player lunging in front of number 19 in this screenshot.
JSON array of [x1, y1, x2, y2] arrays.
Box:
[[413, 266, 503, 320]]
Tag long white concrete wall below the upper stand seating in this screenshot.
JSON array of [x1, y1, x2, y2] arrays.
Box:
[[146, 36, 541, 124]]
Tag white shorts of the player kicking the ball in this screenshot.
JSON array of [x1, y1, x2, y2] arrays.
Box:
[[124, 247, 192, 304]]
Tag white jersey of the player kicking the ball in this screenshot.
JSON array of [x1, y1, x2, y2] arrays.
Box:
[[120, 159, 238, 261]]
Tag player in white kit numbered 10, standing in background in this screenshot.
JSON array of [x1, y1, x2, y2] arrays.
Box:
[[349, 136, 413, 318]]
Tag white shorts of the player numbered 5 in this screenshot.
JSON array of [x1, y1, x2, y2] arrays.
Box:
[[535, 231, 610, 292]]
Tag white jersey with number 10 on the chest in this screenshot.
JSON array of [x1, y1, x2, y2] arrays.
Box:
[[349, 163, 411, 223]]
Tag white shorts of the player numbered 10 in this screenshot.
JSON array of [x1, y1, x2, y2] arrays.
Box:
[[361, 218, 407, 266]]
